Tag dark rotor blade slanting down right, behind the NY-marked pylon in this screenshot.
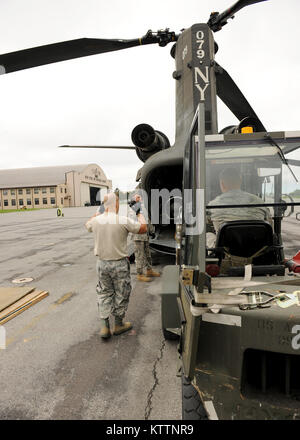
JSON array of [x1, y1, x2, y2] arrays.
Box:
[[216, 63, 266, 131]]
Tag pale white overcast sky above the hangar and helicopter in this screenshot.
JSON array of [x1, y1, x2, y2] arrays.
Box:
[[0, 0, 300, 190]]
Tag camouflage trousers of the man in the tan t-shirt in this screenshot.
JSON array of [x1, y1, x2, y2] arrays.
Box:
[[96, 258, 131, 319]]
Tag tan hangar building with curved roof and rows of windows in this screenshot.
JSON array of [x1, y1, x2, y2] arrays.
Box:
[[0, 163, 112, 209]]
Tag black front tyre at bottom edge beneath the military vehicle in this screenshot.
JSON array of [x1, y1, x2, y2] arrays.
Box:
[[182, 375, 208, 420]]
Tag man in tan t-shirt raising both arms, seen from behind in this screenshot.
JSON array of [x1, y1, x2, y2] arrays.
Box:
[[85, 193, 147, 339]]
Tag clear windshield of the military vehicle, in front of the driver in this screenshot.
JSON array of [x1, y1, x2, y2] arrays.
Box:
[[205, 143, 300, 219]]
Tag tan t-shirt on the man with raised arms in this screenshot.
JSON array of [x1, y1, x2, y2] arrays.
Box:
[[85, 212, 141, 260]]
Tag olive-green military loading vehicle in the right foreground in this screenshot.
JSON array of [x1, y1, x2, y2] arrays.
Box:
[[162, 104, 300, 420]]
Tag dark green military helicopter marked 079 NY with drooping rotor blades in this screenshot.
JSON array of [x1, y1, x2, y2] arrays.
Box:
[[0, 0, 290, 254]]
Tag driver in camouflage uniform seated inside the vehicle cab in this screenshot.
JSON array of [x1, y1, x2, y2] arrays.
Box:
[[206, 167, 272, 248]]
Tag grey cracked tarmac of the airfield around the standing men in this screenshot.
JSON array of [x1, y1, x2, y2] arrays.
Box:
[[0, 207, 300, 420]]
